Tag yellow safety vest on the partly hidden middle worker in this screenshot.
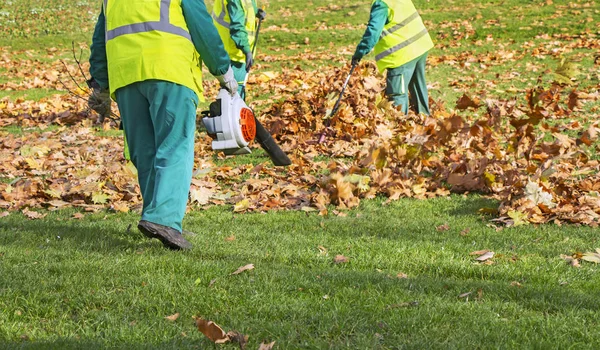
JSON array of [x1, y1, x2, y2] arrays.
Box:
[[212, 0, 256, 62]]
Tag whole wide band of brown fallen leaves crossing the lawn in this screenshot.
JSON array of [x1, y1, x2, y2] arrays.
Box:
[[0, 63, 600, 226]]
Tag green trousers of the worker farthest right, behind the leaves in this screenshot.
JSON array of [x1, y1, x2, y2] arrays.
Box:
[[385, 53, 430, 115]]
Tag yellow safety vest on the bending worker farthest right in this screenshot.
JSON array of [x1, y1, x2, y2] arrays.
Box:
[[373, 0, 433, 72]]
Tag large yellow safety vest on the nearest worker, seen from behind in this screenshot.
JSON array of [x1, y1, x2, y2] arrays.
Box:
[[103, 0, 203, 100]]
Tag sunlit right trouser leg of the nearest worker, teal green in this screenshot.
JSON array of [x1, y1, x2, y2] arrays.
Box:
[[130, 81, 198, 232]]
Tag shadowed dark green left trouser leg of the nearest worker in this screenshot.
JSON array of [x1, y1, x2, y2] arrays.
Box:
[[115, 83, 156, 211]]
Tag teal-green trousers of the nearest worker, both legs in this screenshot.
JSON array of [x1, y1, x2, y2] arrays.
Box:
[[115, 80, 198, 232]]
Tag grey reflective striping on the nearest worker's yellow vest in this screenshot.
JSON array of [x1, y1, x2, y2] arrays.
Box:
[[104, 0, 192, 41]]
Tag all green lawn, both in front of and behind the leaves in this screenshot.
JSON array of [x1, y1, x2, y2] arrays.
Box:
[[0, 0, 600, 349]]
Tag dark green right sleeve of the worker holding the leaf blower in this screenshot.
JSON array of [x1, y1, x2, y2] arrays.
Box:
[[181, 0, 231, 76]]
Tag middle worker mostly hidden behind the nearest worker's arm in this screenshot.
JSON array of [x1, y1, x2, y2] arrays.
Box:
[[212, 0, 266, 100]]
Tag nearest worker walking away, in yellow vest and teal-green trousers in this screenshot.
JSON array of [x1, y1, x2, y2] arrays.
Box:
[[90, 0, 237, 250]]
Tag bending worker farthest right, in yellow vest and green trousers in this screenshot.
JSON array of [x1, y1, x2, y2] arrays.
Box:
[[352, 0, 433, 115]]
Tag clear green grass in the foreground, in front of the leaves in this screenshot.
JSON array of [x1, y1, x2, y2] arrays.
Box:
[[0, 196, 600, 349]]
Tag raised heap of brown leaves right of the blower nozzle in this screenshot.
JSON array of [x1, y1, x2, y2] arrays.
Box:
[[255, 65, 600, 226]]
